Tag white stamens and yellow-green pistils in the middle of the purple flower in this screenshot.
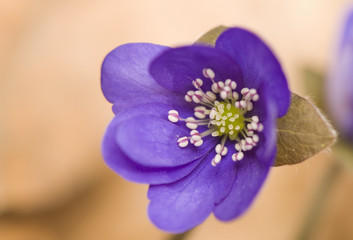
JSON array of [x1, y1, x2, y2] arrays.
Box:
[[168, 68, 263, 166]]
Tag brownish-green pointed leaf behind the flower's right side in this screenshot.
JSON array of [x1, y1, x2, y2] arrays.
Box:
[[274, 93, 337, 166]]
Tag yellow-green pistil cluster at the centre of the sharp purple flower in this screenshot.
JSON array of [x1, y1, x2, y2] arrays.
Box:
[[211, 102, 245, 140]]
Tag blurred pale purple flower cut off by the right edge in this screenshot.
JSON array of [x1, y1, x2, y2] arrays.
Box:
[[326, 8, 353, 140]]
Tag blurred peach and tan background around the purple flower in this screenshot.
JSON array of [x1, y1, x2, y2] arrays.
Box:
[[0, 0, 353, 240]]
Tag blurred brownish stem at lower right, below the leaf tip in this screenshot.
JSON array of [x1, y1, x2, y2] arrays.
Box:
[[296, 159, 343, 240]]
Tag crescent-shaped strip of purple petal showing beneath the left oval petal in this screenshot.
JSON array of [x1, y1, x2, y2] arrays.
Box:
[[102, 116, 200, 184]]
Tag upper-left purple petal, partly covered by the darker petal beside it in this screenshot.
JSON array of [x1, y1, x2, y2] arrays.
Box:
[[101, 43, 179, 113]]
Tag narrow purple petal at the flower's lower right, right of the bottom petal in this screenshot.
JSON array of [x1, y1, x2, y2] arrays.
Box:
[[214, 149, 276, 221]]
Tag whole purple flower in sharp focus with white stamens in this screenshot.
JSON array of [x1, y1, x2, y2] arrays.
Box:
[[102, 28, 290, 232]]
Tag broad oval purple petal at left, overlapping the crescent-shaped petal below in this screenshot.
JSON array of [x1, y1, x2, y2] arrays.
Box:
[[116, 113, 217, 167]]
